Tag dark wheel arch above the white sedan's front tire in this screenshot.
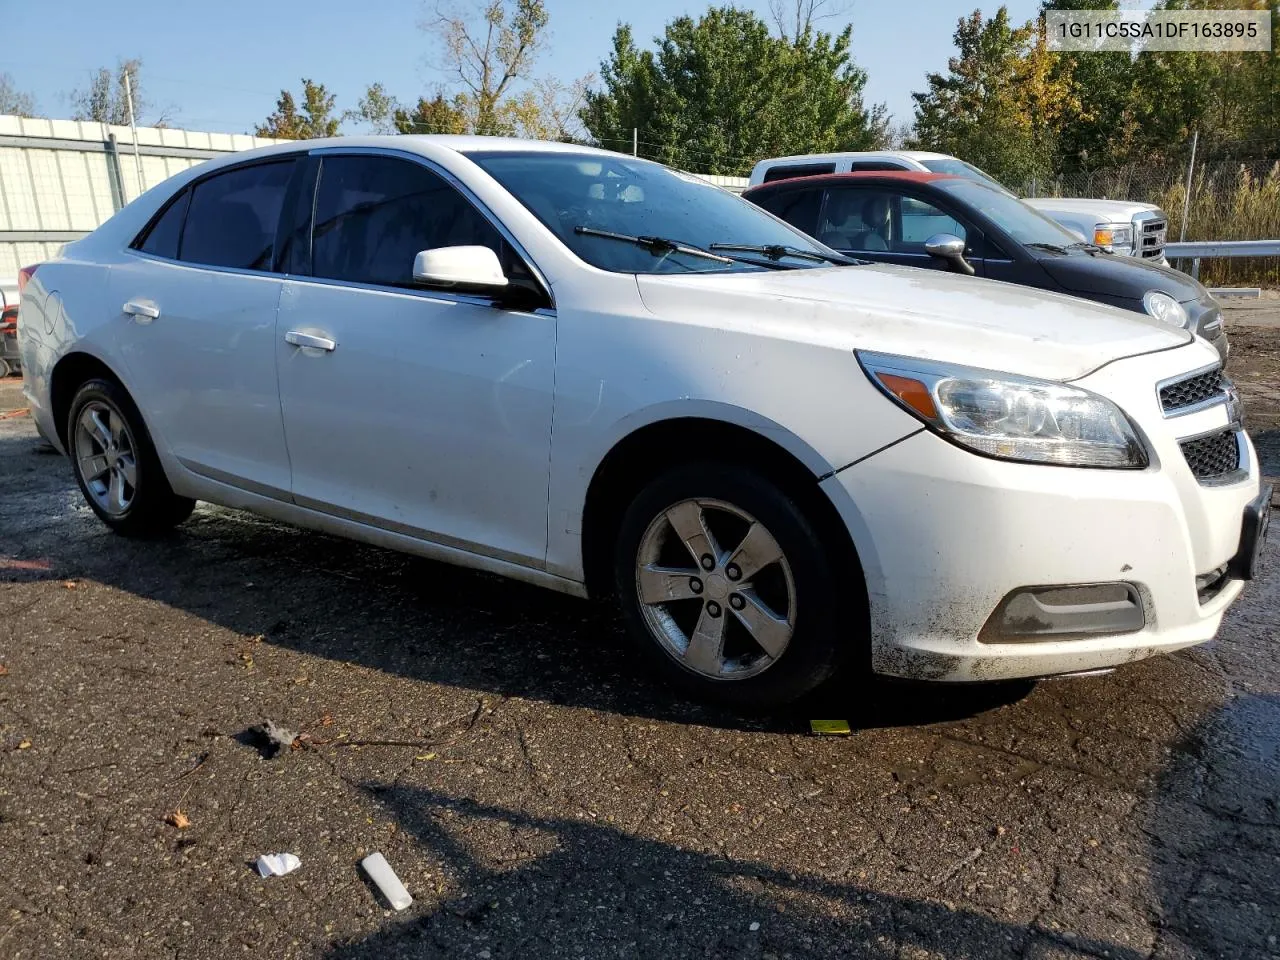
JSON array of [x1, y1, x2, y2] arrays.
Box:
[[582, 415, 865, 609]]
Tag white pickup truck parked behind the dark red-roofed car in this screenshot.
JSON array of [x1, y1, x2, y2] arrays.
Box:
[[751, 150, 1169, 265]]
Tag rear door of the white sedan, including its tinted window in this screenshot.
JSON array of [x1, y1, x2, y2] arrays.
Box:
[[110, 157, 296, 497]]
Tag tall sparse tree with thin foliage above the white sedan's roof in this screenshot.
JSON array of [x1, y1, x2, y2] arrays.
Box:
[[425, 0, 550, 133]]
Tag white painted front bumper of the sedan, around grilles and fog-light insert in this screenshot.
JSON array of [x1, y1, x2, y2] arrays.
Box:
[[823, 342, 1260, 681]]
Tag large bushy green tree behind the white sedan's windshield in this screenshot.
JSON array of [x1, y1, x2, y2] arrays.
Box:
[[581, 8, 888, 174]]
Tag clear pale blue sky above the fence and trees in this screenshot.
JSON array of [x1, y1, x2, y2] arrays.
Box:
[[0, 0, 1038, 133]]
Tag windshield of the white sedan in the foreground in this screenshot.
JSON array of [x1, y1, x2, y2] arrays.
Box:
[[467, 151, 838, 274]]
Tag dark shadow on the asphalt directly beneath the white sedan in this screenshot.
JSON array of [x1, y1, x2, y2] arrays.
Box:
[[0, 438, 1030, 731]]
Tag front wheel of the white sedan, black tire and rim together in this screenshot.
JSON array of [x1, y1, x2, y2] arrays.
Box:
[[614, 462, 865, 708]]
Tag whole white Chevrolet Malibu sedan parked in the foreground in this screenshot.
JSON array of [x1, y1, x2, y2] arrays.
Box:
[[12, 137, 1270, 705]]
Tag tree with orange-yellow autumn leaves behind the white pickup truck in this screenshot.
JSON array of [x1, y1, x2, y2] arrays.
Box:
[[911, 6, 1079, 188]]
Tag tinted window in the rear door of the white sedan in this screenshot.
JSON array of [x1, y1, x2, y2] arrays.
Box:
[[178, 159, 294, 270]]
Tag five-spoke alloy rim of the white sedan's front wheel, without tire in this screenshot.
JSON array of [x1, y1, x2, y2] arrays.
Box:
[[635, 498, 796, 680]]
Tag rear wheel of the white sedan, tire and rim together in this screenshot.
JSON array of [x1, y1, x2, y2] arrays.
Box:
[[67, 379, 196, 536]]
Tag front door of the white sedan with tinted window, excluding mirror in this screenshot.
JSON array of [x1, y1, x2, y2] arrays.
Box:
[[275, 154, 556, 567]]
